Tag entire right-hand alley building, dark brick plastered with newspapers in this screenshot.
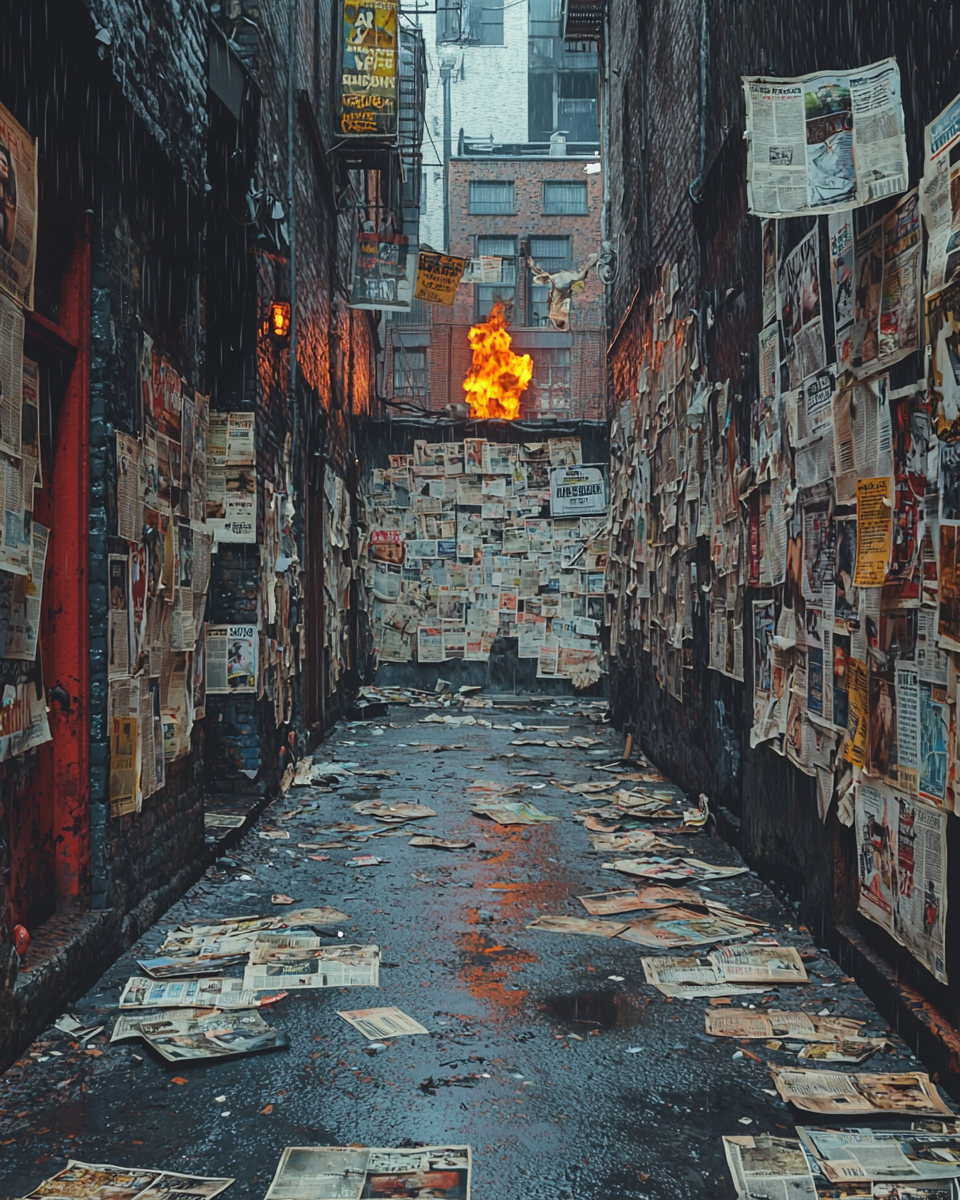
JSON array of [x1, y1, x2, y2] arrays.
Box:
[[595, 0, 960, 1086]]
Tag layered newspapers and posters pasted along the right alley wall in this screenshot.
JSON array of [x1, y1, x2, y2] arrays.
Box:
[[606, 60, 960, 998]]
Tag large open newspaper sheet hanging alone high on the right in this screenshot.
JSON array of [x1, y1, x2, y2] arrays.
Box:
[[743, 58, 908, 217]]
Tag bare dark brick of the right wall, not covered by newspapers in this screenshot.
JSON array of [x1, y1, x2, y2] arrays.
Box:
[[607, 0, 960, 1020]]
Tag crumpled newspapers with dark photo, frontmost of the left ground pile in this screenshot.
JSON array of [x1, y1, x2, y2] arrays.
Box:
[[110, 1008, 289, 1062]]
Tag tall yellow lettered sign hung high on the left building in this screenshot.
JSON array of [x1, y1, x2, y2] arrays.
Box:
[[340, 0, 398, 138]]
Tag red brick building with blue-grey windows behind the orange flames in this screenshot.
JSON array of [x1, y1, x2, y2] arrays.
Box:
[[384, 137, 606, 420]]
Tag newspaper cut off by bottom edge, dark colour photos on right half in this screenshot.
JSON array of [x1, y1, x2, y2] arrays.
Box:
[[266, 1146, 472, 1200]]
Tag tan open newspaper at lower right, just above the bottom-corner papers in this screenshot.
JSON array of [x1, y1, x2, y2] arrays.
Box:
[[770, 1067, 953, 1117]]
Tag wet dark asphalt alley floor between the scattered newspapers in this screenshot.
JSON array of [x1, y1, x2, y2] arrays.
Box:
[[0, 701, 950, 1200]]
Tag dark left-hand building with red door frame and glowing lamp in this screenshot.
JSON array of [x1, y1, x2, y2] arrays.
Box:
[[0, 0, 422, 1064]]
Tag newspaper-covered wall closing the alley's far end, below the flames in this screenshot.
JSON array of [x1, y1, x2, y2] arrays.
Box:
[[361, 421, 608, 690]]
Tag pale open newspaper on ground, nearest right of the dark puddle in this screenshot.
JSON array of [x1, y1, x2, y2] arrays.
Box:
[[641, 942, 808, 1000]]
